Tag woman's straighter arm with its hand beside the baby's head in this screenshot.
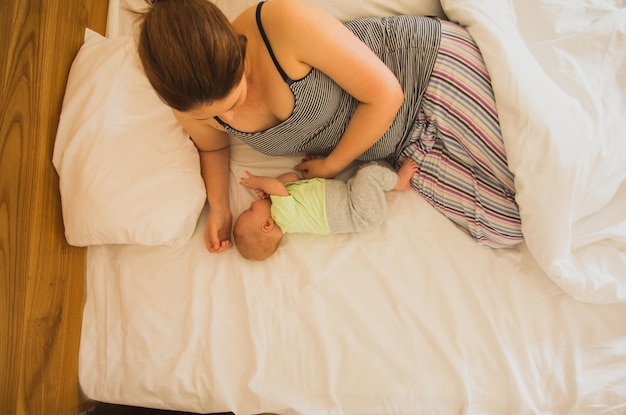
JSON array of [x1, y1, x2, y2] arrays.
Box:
[[174, 111, 232, 253]]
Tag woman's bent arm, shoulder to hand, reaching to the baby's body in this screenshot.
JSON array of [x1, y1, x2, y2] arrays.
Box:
[[263, 0, 404, 178]]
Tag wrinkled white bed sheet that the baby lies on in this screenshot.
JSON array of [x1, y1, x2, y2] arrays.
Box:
[[80, 148, 626, 414]]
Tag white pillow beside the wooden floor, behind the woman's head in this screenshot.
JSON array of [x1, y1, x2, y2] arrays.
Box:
[[53, 30, 206, 247]]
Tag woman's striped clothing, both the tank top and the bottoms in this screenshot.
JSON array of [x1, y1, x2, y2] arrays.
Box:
[[216, 2, 522, 247]]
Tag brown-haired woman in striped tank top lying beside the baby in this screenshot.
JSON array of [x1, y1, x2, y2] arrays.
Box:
[[138, 0, 522, 252]]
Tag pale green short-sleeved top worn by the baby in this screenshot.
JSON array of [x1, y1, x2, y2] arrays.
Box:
[[270, 178, 330, 235]]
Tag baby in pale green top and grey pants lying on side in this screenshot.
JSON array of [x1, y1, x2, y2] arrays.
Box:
[[233, 159, 417, 261]]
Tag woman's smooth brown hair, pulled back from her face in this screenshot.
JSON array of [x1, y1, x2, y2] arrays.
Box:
[[137, 0, 246, 112]]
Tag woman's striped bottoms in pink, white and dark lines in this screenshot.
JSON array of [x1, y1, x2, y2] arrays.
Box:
[[402, 21, 523, 247]]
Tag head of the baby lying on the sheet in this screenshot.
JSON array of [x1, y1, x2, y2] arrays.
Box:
[[233, 199, 283, 261]]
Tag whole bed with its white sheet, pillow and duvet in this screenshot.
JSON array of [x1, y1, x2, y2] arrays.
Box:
[[53, 0, 626, 414]]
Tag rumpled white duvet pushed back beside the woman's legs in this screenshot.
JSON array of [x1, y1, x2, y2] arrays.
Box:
[[442, 0, 626, 303]]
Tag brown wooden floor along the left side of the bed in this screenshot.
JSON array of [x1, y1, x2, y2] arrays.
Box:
[[0, 0, 108, 415]]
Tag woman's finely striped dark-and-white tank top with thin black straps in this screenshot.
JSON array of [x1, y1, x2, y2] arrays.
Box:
[[217, 12, 441, 161]]
